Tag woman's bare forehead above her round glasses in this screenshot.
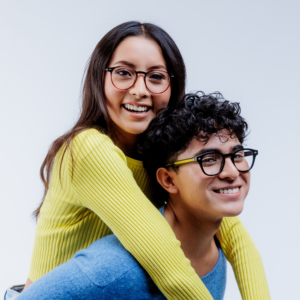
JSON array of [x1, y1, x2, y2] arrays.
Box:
[[110, 36, 166, 70]]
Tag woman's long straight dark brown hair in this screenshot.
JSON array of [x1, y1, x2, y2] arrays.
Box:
[[33, 21, 186, 217]]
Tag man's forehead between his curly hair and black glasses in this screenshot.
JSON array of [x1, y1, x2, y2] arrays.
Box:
[[178, 130, 241, 160]]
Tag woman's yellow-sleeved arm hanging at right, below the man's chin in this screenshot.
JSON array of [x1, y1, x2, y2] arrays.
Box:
[[217, 217, 271, 300]]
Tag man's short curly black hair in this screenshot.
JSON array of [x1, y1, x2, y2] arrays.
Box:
[[140, 91, 248, 207]]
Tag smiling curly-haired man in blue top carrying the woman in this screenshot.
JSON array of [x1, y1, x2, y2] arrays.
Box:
[[11, 94, 264, 300]]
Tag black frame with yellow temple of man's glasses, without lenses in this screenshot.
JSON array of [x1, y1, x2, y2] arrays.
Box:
[[166, 148, 258, 176]]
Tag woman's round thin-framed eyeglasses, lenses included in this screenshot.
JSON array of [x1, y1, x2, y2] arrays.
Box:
[[105, 67, 174, 94]]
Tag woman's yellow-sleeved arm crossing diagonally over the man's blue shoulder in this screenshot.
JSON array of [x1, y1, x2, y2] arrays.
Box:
[[69, 130, 212, 300]]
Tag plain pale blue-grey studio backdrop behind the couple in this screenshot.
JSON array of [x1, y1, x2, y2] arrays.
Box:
[[0, 0, 300, 300]]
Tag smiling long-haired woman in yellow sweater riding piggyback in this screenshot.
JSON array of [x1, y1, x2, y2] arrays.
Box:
[[22, 22, 268, 300]]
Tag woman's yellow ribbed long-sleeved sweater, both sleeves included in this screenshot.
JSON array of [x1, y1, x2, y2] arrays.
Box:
[[29, 129, 270, 300]]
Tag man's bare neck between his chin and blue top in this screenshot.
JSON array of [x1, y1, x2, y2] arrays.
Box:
[[165, 201, 222, 277]]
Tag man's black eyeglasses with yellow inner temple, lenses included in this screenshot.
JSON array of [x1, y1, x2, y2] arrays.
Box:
[[166, 148, 258, 176]]
